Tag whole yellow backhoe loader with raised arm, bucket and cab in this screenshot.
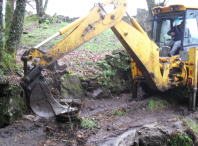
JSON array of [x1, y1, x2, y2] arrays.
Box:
[[20, 0, 198, 117]]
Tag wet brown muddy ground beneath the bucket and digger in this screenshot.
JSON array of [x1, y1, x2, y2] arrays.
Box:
[[0, 89, 198, 146]]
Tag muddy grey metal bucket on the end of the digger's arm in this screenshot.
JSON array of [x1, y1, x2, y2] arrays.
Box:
[[21, 66, 78, 117]]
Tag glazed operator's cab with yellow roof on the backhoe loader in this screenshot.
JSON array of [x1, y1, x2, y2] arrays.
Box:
[[151, 5, 198, 57]]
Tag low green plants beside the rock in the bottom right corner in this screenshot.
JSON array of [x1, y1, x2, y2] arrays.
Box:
[[167, 133, 193, 146]]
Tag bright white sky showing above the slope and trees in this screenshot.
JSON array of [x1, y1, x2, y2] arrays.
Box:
[[27, 0, 198, 17]]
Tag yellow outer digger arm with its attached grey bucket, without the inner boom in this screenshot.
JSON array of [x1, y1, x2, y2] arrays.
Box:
[[20, 0, 127, 117]]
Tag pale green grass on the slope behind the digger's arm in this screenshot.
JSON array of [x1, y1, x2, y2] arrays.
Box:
[[21, 15, 122, 52]]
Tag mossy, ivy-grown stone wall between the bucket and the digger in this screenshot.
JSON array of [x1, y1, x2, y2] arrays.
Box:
[[61, 50, 132, 99]]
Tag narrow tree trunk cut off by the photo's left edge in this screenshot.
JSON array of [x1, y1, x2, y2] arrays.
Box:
[[0, 0, 3, 61]]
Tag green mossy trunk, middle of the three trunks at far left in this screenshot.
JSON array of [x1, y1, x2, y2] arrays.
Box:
[[5, 0, 15, 37]]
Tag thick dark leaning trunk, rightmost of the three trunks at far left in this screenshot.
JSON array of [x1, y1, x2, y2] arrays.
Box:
[[5, 0, 26, 58]]
